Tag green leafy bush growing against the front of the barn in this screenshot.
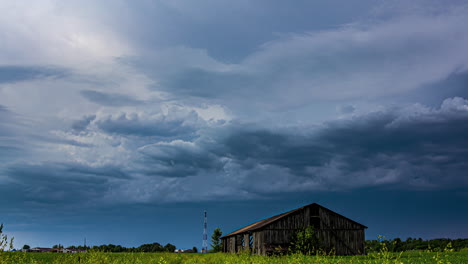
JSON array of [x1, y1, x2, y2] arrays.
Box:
[[289, 226, 320, 255]]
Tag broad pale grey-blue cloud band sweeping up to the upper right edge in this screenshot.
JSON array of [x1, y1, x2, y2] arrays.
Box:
[[131, 7, 468, 109]]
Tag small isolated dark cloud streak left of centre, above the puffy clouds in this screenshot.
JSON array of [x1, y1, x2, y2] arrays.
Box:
[[81, 90, 143, 107]]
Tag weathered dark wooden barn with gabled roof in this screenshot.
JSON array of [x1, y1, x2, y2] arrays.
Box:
[[221, 203, 367, 255]]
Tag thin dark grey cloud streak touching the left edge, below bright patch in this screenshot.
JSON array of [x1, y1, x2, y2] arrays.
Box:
[[0, 65, 68, 83]]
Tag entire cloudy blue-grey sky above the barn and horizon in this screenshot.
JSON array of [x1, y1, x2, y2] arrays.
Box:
[[0, 0, 468, 248]]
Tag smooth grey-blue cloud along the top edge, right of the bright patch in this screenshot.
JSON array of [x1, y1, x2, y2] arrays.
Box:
[[104, 0, 374, 61]]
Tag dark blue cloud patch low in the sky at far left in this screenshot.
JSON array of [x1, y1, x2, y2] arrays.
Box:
[[3, 163, 128, 205]]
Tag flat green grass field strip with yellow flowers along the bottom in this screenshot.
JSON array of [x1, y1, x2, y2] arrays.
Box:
[[0, 251, 468, 264]]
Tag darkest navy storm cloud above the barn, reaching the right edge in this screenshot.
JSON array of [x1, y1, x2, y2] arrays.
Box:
[[133, 98, 468, 192]]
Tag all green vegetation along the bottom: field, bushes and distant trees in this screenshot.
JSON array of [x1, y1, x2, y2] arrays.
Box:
[[0, 225, 468, 264]]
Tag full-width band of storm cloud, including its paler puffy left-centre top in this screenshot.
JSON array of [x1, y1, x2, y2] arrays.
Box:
[[1, 98, 468, 203]]
